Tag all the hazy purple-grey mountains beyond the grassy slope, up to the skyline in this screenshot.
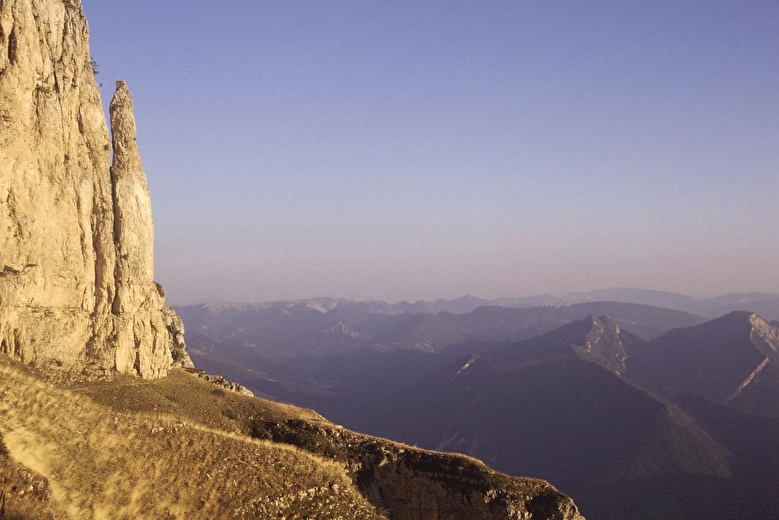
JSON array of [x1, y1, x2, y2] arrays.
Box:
[[177, 289, 779, 520]]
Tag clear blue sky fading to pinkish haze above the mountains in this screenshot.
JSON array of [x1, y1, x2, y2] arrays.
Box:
[[83, 0, 779, 304]]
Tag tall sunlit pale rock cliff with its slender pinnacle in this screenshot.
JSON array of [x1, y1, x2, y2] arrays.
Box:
[[0, 0, 188, 378]]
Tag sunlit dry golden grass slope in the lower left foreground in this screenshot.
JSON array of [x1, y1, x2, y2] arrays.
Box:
[[0, 361, 379, 520]]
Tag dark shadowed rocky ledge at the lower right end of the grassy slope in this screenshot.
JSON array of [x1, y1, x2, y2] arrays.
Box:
[[248, 419, 584, 520]]
